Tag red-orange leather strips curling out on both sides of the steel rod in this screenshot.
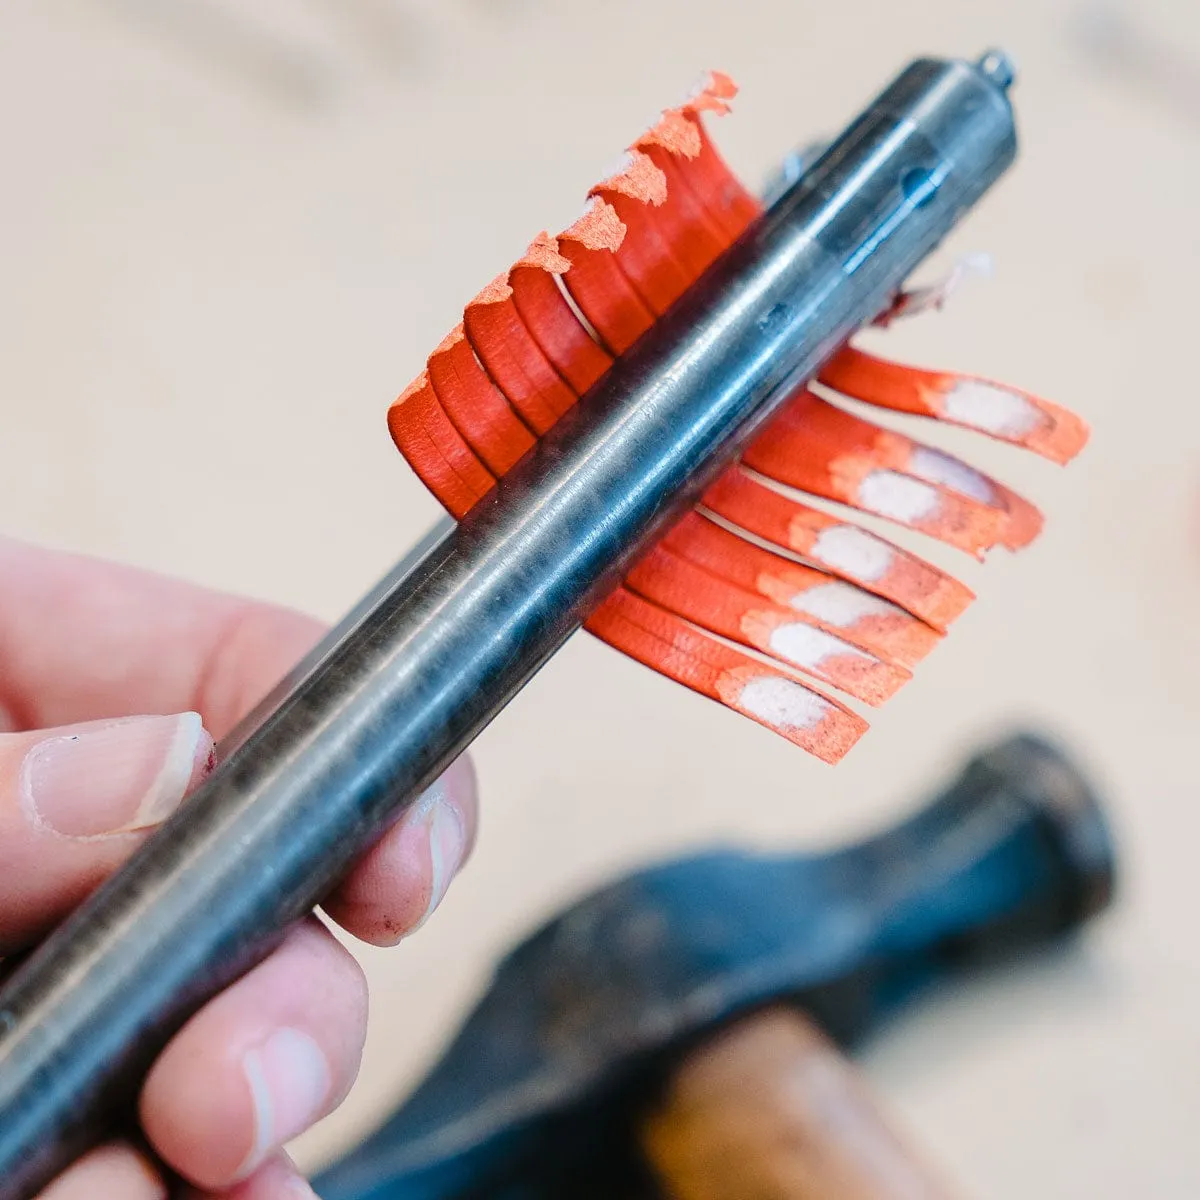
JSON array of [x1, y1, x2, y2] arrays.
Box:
[[389, 73, 1087, 762]]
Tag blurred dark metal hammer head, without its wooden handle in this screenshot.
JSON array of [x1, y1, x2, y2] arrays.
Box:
[[316, 736, 1114, 1200]]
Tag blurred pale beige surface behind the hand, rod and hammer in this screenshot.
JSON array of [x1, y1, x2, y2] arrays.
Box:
[[0, 0, 1200, 1200]]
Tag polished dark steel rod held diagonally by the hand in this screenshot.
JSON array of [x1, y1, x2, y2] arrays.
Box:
[[0, 54, 1015, 1200]]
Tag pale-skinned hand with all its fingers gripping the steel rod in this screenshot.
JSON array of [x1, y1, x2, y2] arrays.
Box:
[[0, 539, 476, 1200]]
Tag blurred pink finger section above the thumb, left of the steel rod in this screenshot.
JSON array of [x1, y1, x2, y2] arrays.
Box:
[[0, 538, 322, 738]]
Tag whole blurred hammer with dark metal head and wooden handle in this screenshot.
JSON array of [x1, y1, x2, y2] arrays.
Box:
[[316, 736, 1114, 1200]]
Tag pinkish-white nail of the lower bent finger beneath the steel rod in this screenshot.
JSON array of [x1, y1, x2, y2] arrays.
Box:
[[239, 1028, 332, 1176]]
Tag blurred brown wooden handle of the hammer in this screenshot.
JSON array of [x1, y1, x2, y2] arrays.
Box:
[[641, 1008, 952, 1200]]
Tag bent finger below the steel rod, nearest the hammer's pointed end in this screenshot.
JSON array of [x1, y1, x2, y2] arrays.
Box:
[[140, 919, 367, 1200]]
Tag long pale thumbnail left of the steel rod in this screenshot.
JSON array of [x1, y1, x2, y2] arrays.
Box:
[[20, 713, 212, 839]]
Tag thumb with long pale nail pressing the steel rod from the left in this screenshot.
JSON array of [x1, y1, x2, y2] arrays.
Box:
[[0, 713, 212, 955]]
